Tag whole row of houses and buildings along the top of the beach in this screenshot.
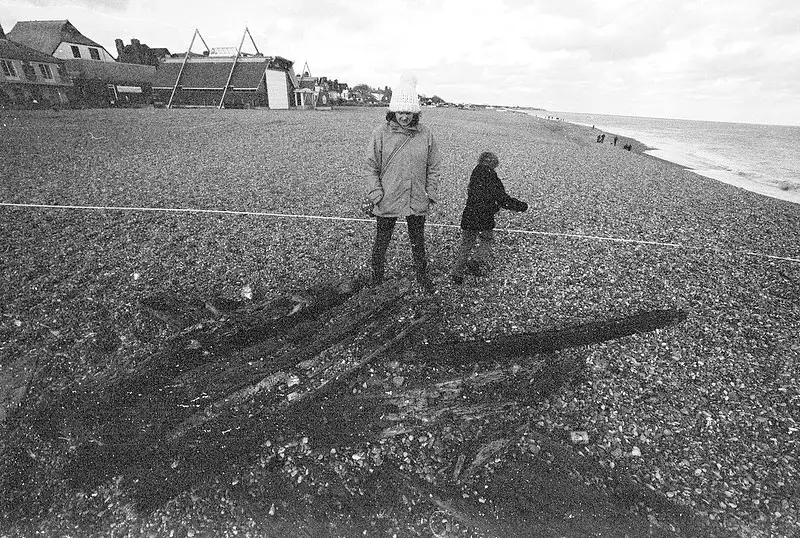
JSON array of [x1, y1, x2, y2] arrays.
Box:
[[0, 20, 348, 109]]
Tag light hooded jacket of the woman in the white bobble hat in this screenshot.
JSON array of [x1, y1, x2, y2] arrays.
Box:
[[365, 122, 442, 217]]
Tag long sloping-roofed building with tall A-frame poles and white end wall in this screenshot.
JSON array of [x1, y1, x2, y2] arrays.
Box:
[[153, 37, 298, 109]]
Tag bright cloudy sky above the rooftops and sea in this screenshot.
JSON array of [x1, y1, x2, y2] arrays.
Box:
[[6, 0, 800, 125]]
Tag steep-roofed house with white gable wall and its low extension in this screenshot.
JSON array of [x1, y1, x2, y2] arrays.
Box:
[[8, 20, 156, 107]]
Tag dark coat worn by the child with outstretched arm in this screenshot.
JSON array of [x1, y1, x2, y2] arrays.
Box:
[[461, 164, 528, 230]]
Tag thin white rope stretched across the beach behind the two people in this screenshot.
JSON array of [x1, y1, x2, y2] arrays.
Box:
[[0, 202, 800, 263]]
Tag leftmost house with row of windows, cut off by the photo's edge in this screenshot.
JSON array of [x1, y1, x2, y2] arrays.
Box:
[[0, 22, 72, 108]]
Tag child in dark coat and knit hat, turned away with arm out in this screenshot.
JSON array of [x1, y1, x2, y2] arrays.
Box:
[[451, 151, 528, 285]]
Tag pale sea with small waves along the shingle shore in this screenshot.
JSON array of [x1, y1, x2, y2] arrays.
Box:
[[527, 110, 800, 204]]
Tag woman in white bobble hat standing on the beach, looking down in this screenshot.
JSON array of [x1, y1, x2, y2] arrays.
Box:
[[366, 74, 442, 293]]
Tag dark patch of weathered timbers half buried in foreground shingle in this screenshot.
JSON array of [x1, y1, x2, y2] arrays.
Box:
[[2, 279, 732, 536]]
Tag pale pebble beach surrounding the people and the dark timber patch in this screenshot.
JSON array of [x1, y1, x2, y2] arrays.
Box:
[[0, 108, 800, 537]]
